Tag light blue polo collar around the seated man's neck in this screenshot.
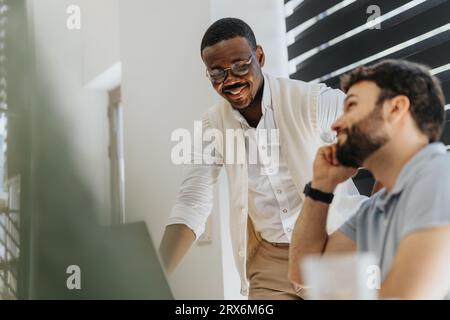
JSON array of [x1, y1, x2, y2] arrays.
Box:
[[377, 142, 447, 211]]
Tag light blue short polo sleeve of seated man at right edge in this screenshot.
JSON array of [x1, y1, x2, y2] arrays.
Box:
[[400, 157, 450, 238]]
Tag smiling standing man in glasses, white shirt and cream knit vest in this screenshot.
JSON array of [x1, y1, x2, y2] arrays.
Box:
[[160, 18, 364, 299]]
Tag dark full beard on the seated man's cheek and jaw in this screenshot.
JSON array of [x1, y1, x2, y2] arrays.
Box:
[[336, 107, 389, 168]]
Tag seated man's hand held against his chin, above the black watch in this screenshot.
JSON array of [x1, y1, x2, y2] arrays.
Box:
[[311, 144, 358, 193]]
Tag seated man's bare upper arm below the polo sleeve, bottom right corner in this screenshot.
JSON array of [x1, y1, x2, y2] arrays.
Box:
[[379, 226, 450, 299]]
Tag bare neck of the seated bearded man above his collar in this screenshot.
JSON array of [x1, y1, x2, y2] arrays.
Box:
[[364, 138, 428, 192]]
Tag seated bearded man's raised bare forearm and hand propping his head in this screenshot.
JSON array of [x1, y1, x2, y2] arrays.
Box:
[[288, 145, 356, 285]]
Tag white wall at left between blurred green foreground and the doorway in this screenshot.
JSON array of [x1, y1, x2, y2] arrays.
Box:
[[28, 0, 110, 223]]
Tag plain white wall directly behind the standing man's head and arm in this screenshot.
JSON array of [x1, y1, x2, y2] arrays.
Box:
[[119, 0, 227, 299]]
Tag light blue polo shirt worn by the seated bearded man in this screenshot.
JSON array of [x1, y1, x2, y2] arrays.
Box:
[[340, 142, 450, 299]]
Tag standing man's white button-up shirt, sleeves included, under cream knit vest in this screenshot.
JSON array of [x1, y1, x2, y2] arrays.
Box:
[[168, 77, 345, 243]]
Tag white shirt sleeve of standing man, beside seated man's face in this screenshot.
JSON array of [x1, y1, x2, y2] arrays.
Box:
[[317, 85, 345, 143]]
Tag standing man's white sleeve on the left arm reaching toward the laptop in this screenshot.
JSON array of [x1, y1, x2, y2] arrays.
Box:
[[167, 112, 223, 239]]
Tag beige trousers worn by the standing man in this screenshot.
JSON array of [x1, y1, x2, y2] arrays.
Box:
[[247, 240, 301, 300]]
